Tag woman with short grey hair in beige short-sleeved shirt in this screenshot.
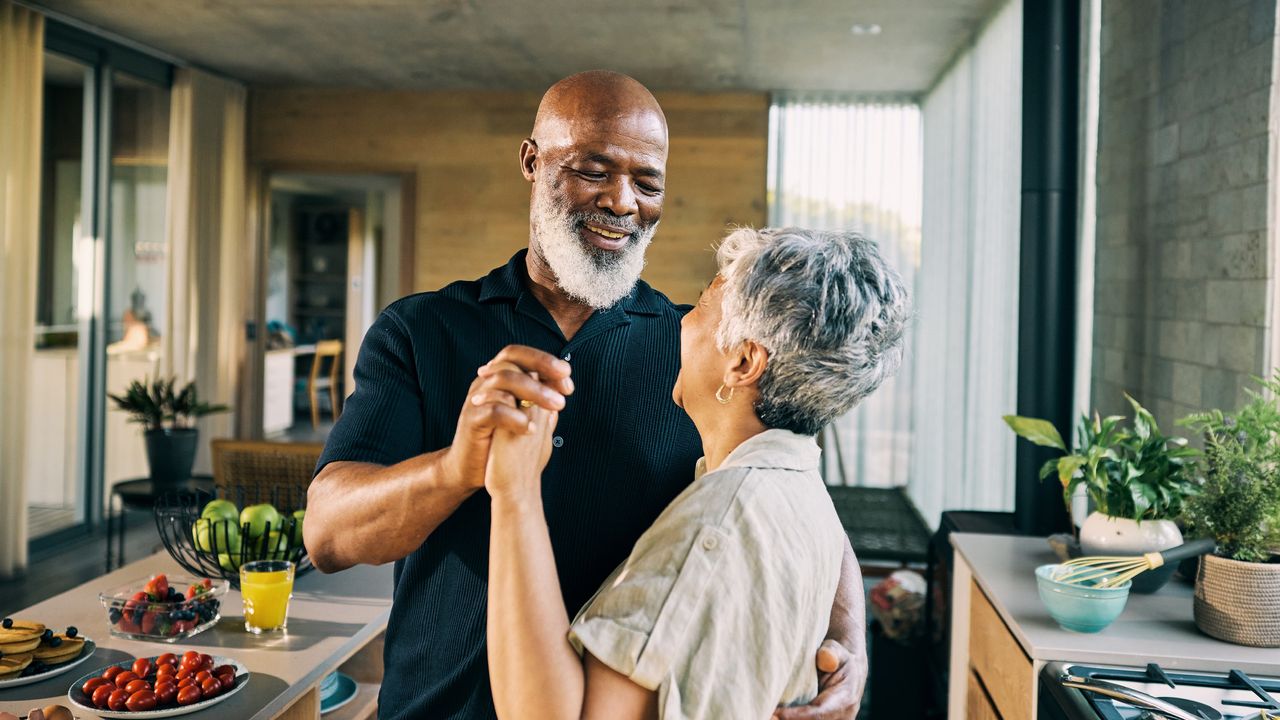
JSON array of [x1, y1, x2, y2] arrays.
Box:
[[485, 228, 909, 720]]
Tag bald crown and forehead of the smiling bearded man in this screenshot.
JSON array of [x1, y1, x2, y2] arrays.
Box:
[[531, 70, 667, 159]]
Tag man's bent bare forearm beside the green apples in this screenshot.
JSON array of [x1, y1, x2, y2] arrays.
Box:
[[302, 450, 477, 573]]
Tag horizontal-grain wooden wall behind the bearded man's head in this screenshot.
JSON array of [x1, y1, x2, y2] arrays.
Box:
[[248, 88, 768, 302]]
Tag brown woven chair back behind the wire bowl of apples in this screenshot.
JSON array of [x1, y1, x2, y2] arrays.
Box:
[[211, 439, 324, 497]]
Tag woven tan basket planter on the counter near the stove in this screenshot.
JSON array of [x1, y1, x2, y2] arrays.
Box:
[[1196, 555, 1280, 647]]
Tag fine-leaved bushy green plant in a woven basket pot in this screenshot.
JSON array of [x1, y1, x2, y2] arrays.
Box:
[[1181, 372, 1280, 647]]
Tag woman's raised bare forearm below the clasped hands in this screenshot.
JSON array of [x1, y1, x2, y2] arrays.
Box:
[[488, 496, 586, 720]]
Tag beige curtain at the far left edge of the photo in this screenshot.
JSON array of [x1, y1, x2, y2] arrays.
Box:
[[0, 0, 45, 578]]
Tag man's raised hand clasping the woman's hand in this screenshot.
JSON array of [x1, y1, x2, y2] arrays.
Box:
[[445, 345, 573, 488]]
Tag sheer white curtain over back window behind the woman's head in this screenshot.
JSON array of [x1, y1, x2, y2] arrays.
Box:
[[768, 96, 922, 487]]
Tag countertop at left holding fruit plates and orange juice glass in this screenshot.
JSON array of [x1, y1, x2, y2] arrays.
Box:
[[0, 552, 392, 720]]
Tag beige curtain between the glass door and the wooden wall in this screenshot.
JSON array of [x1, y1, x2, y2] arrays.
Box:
[[161, 68, 251, 473]]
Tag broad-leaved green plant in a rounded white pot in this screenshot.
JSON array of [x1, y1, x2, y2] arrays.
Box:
[[1005, 395, 1199, 592]]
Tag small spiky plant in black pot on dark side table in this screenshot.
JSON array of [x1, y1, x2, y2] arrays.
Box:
[[108, 378, 228, 483]]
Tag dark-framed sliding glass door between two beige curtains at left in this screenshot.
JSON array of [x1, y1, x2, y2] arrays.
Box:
[[27, 20, 172, 547]]
